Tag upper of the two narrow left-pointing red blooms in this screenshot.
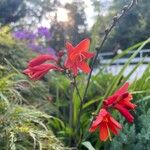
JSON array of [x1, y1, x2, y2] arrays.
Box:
[[28, 54, 57, 67]]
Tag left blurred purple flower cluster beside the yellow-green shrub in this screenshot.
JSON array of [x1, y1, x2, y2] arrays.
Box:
[[13, 30, 36, 41]]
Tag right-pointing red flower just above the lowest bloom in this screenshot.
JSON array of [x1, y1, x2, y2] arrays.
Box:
[[103, 83, 136, 123]]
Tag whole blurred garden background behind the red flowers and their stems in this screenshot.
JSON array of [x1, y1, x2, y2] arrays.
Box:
[[0, 0, 150, 150]]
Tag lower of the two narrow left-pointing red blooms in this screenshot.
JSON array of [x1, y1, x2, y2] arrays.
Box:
[[23, 64, 63, 80]]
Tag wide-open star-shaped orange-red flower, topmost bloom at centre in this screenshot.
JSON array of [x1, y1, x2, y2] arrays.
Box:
[[65, 39, 94, 76]]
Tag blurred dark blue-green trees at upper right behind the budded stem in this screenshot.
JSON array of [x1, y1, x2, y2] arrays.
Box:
[[97, 0, 150, 51]]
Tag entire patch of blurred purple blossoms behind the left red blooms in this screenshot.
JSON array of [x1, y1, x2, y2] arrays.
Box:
[[13, 27, 56, 55]]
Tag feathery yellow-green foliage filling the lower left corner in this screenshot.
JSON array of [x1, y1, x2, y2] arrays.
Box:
[[0, 68, 64, 150]]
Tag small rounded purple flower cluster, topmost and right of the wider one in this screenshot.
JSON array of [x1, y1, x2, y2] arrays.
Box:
[[37, 27, 51, 39]]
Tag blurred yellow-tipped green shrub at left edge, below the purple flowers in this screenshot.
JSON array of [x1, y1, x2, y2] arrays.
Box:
[[0, 26, 32, 69]]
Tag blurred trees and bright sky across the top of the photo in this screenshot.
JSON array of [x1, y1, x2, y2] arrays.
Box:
[[0, 0, 150, 52]]
